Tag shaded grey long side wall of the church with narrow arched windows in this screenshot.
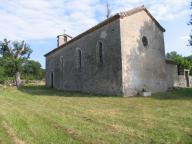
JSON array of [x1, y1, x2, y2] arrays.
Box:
[[46, 19, 122, 95]]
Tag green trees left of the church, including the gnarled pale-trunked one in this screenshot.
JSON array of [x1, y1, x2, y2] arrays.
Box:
[[0, 39, 44, 87]]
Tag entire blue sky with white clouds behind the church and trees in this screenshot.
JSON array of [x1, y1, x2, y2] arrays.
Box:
[[0, 0, 192, 67]]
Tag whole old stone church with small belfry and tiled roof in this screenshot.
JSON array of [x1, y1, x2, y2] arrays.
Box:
[[45, 6, 190, 96]]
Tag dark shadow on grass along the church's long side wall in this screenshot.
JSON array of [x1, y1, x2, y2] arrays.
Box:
[[19, 85, 120, 98]]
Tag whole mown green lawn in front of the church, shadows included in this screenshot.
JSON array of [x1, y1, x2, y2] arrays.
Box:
[[0, 86, 192, 144]]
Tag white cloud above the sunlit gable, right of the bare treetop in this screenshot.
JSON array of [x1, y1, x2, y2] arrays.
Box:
[[111, 0, 190, 20]]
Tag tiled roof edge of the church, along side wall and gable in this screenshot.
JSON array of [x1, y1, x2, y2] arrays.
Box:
[[44, 6, 165, 57]]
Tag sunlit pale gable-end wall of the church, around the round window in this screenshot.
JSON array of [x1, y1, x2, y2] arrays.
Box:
[[120, 11, 167, 96]]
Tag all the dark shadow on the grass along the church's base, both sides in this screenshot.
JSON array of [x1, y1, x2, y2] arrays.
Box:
[[19, 85, 192, 100]]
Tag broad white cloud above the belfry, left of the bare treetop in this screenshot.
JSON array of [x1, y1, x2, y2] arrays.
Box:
[[0, 0, 102, 40]]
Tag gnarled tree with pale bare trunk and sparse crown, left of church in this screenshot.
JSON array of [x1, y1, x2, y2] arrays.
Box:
[[0, 39, 32, 88]]
